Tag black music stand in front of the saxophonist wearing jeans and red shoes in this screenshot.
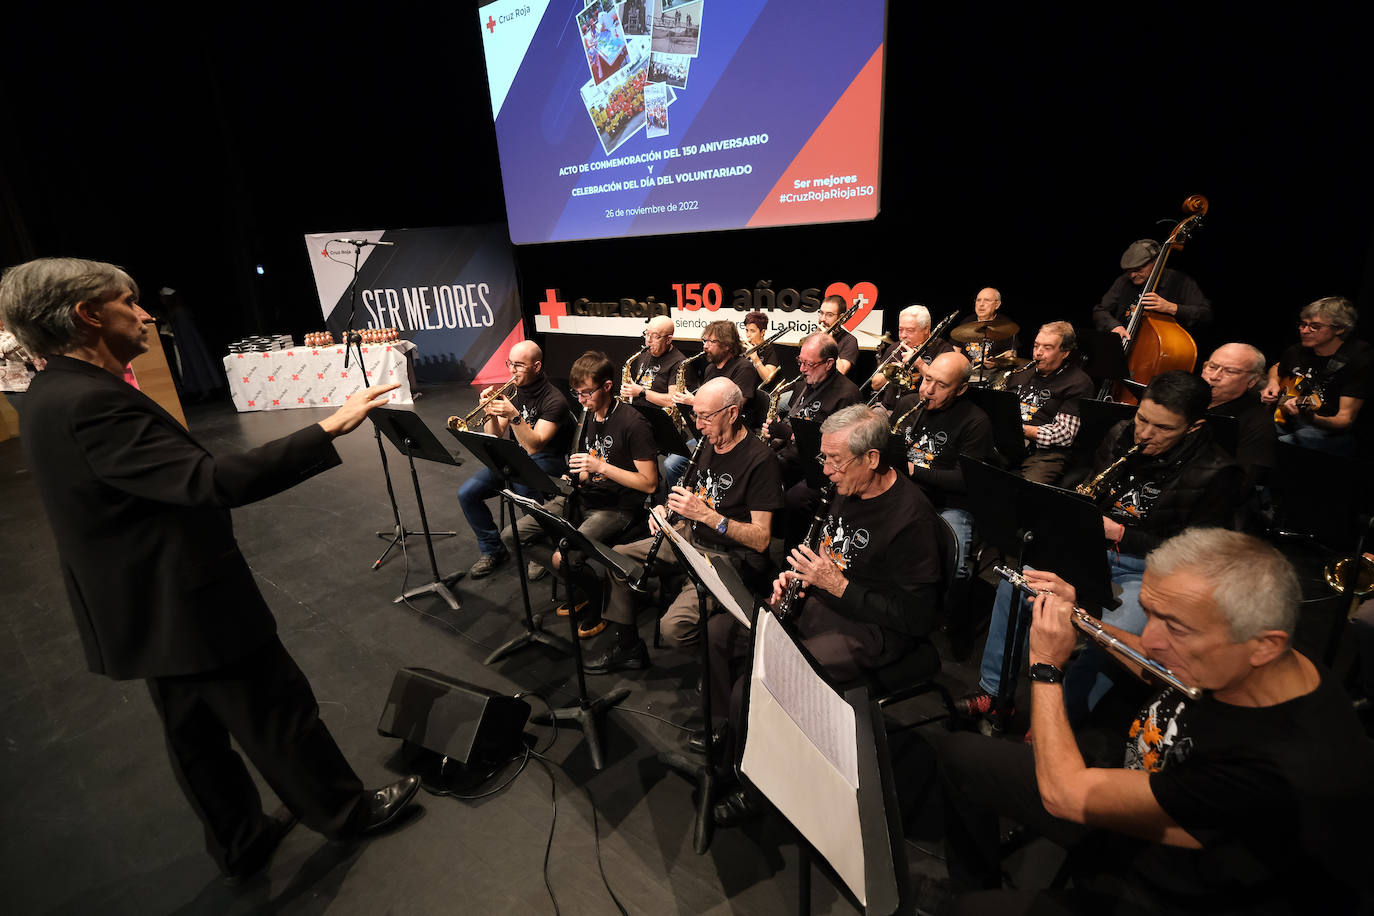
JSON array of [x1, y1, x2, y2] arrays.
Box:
[[959, 455, 1116, 722]]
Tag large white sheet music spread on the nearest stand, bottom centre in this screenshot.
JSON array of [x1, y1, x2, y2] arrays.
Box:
[[739, 614, 868, 906]]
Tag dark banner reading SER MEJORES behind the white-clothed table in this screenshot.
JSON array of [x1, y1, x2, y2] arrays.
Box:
[[305, 224, 525, 385]]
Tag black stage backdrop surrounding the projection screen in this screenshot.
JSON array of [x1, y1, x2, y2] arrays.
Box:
[[0, 1, 1374, 373]]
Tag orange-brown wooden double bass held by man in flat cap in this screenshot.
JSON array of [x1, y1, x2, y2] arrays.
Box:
[[1099, 194, 1208, 404]]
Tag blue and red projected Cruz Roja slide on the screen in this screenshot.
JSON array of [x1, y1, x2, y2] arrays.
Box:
[[478, 0, 886, 244]]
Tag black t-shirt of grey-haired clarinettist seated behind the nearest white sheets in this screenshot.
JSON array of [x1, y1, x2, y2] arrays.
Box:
[[802, 474, 940, 636]]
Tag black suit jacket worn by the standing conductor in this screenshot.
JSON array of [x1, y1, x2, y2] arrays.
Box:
[[19, 357, 339, 678]]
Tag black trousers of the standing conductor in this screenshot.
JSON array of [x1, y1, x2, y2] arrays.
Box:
[[148, 636, 363, 873]]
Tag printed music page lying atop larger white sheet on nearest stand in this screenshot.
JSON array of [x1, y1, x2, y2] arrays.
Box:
[[754, 614, 859, 788]]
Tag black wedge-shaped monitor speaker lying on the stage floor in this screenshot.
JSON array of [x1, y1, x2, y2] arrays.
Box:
[[376, 667, 530, 766]]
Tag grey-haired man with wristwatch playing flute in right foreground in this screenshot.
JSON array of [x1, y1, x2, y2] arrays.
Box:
[[934, 529, 1374, 916]]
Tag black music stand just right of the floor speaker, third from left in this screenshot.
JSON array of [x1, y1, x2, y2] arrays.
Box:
[[502, 489, 640, 770]]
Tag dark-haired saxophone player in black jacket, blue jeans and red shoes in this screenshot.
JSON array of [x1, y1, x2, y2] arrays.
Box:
[[963, 371, 1245, 714]]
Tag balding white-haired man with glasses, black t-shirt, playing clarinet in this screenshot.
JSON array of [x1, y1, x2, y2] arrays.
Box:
[[583, 379, 782, 674]]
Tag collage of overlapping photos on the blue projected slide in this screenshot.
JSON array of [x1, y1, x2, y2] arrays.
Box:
[[574, 0, 706, 154]]
